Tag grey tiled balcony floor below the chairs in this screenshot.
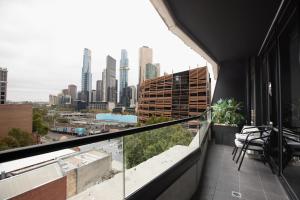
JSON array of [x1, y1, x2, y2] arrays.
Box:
[[193, 144, 288, 200]]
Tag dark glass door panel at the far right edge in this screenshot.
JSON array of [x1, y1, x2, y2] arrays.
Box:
[[280, 7, 300, 197]]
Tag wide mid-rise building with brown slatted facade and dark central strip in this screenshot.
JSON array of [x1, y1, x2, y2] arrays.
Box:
[[138, 67, 210, 122]]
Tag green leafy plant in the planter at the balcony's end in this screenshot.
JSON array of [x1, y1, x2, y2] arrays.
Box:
[[212, 98, 245, 126]]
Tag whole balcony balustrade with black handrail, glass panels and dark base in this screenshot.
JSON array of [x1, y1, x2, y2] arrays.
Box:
[[0, 110, 210, 200]]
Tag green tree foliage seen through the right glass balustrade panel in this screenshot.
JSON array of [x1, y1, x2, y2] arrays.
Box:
[[124, 118, 194, 168]]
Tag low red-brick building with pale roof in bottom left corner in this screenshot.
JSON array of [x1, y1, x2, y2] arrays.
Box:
[[0, 163, 67, 200]]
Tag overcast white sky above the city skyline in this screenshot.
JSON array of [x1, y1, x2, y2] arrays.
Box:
[[0, 0, 205, 101]]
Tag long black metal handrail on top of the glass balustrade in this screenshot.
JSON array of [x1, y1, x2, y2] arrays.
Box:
[[0, 108, 210, 163]]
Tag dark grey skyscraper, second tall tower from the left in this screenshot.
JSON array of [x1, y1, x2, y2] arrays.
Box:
[[106, 55, 117, 103]]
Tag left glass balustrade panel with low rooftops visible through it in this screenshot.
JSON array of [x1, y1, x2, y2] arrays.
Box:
[[0, 138, 124, 200]]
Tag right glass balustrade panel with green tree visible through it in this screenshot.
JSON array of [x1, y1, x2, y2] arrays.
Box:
[[124, 115, 208, 197]]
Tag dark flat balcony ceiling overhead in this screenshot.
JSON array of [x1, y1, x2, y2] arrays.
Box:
[[165, 0, 280, 62]]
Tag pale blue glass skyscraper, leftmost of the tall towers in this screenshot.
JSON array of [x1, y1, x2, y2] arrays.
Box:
[[81, 48, 92, 101]]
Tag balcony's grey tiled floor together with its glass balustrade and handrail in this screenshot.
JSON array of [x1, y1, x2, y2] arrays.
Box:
[[0, 109, 288, 200]]
